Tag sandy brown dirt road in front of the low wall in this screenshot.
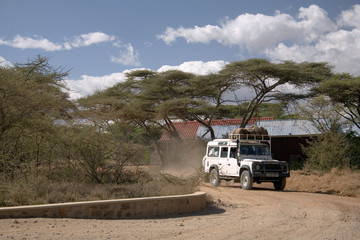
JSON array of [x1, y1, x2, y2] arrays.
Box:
[[0, 183, 360, 240]]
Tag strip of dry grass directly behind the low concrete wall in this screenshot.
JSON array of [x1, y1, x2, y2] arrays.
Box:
[[0, 172, 201, 206]]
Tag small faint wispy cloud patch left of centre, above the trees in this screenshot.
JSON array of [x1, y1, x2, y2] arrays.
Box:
[[111, 42, 141, 67]]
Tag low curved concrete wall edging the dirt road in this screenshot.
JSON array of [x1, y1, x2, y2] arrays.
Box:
[[0, 192, 206, 219]]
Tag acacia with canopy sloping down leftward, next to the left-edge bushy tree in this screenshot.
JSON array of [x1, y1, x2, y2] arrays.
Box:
[[79, 70, 190, 162]]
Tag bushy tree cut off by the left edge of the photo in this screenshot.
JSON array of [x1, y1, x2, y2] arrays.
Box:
[[0, 56, 73, 174]]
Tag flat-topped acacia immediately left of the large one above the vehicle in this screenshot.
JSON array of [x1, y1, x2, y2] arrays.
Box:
[[125, 71, 234, 141]]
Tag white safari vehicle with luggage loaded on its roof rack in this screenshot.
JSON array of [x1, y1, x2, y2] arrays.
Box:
[[202, 127, 290, 190]]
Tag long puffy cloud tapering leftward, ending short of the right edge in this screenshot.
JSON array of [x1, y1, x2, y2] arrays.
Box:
[[158, 5, 335, 51]]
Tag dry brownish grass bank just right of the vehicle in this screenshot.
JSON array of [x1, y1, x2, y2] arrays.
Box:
[[286, 168, 360, 197]]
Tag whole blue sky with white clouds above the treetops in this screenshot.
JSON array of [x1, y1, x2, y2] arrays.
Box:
[[0, 0, 360, 99]]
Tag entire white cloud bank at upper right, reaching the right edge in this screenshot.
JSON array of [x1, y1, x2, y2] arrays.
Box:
[[158, 4, 360, 76]]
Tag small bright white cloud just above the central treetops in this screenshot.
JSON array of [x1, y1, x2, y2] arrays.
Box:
[[157, 61, 228, 75]]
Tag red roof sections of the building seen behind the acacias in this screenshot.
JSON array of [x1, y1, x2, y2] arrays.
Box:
[[159, 117, 274, 141]]
